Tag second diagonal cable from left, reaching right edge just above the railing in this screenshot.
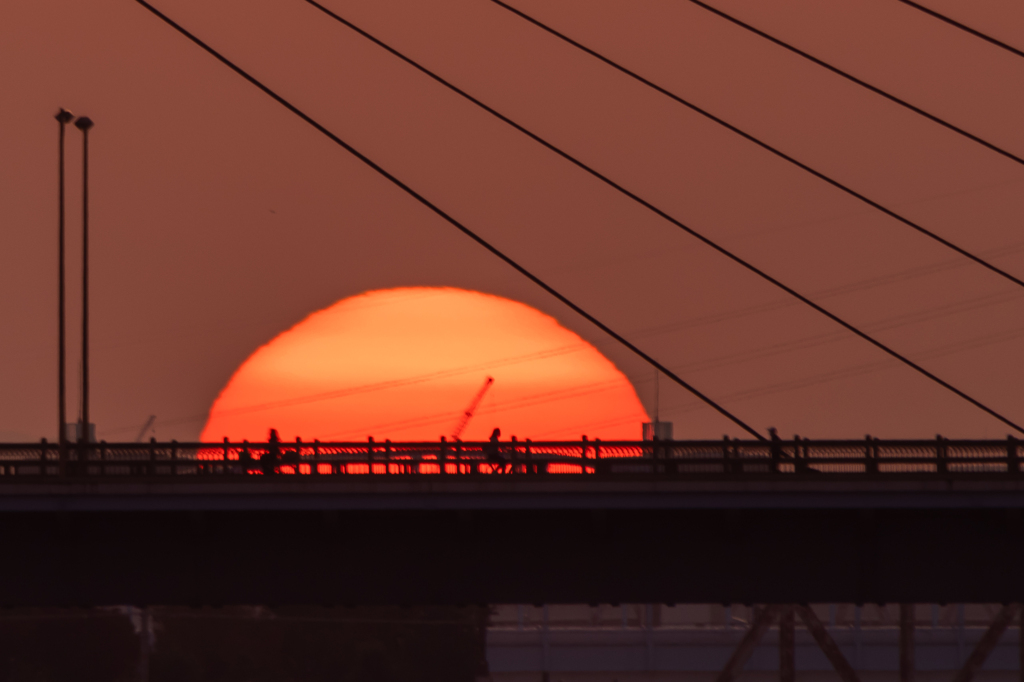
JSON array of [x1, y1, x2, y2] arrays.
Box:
[[299, 0, 1024, 432]]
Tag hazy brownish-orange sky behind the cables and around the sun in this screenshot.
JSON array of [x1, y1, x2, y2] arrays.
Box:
[[0, 0, 1024, 440]]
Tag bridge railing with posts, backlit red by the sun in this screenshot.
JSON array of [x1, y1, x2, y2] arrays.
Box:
[[0, 437, 1021, 481]]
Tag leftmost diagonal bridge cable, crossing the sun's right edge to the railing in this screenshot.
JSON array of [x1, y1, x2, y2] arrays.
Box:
[[128, 0, 765, 440]]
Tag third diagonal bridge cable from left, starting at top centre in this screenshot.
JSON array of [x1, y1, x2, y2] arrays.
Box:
[[483, 0, 1024, 288]]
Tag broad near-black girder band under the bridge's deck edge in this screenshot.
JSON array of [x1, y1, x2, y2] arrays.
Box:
[[0, 509, 1024, 606]]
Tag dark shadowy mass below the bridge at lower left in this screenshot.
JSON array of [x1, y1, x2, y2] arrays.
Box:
[[0, 607, 486, 682]]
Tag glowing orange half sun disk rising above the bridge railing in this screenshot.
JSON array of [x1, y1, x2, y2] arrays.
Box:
[[201, 287, 648, 441]]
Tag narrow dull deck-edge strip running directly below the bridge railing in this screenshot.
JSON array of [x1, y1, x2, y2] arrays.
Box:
[[0, 474, 1024, 512]]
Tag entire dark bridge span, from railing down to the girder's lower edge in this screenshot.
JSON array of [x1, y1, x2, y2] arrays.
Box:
[[0, 441, 1024, 606]]
